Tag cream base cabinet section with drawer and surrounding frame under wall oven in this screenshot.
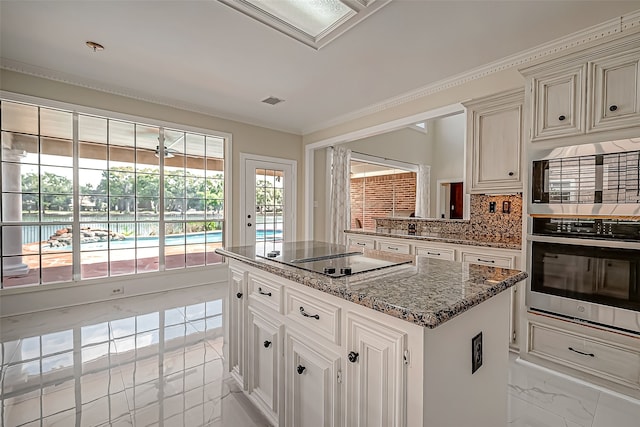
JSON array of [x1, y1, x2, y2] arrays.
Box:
[[521, 312, 640, 398]]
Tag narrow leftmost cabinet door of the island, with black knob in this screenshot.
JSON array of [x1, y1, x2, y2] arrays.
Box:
[[228, 267, 247, 390]]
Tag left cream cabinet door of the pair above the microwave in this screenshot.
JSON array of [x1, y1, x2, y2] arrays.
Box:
[[531, 66, 586, 141]]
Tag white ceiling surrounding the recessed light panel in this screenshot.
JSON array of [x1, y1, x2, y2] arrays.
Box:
[[0, 0, 640, 134]]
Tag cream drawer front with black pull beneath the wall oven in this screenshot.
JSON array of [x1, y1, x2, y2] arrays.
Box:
[[528, 323, 640, 388]]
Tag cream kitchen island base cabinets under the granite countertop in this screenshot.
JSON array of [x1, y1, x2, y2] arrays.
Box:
[[225, 259, 509, 427]]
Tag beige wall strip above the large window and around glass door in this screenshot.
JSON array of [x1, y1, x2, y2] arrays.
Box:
[[0, 70, 306, 245]]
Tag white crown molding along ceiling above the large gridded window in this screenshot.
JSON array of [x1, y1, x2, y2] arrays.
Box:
[[0, 57, 301, 135]]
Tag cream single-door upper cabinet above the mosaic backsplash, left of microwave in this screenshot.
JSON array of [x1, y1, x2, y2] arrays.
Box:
[[464, 89, 524, 194]]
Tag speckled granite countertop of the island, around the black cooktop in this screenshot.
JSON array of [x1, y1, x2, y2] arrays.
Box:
[[216, 242, 527, 328]]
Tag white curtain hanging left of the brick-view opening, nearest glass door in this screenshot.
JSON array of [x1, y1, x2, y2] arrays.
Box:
[[329, 147, 351, 245]]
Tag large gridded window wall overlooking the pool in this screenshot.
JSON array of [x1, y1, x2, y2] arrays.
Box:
[[0, 100, 225, 288]]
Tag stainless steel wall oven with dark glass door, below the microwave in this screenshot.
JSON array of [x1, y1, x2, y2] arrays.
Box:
[[527, 218, 640, 334]]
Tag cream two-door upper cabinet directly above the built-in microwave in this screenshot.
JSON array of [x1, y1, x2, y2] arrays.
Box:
[[520, 34, 640, 143]]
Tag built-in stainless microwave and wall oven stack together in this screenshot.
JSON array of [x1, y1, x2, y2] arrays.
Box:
[[527, 139, 640, 334]]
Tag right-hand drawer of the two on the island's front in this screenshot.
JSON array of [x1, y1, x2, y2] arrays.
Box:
[[285, 288, 340, 344]]
